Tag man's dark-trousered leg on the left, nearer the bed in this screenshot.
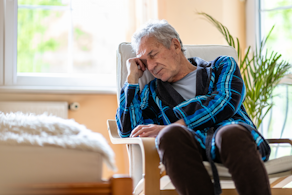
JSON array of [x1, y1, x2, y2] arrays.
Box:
[[157, 124, 214, 195]]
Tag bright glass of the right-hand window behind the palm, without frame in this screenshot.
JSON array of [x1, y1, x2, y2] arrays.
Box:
[[260, 0, 292, 163]]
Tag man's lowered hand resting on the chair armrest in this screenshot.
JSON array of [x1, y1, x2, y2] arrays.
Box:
[[130, 125, 165, 137]]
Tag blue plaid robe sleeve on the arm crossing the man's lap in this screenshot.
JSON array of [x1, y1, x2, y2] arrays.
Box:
[[173, 56, 246, 130]]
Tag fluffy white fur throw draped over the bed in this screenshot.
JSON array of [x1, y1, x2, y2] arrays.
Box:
[[0, 112, 116, 170]]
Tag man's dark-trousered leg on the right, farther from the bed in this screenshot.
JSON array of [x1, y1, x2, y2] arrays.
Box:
[[215, 125, 271, 195]]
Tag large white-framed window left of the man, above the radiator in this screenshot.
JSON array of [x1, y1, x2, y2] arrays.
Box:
[[0, 0, 127, 93]]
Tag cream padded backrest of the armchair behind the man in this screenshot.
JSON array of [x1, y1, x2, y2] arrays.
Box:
[[117, 43, 238, 98]]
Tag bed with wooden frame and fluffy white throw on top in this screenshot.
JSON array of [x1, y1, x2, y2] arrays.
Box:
[[0, 113, 132, 194]]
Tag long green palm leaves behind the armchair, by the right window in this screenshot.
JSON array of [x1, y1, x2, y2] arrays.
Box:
[[198, 13, 291, 127]]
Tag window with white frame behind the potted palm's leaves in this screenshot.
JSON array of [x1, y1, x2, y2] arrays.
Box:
[[247, 0, 292, 161]]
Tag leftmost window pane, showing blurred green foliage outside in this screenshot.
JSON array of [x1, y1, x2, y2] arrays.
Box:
[[17, 9, 70, 73]]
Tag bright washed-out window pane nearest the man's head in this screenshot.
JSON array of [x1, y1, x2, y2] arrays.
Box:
[[71, 0, 125, 73]]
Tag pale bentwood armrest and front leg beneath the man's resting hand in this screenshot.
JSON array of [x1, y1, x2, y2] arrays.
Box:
[[107, 120, 160, 195]]
